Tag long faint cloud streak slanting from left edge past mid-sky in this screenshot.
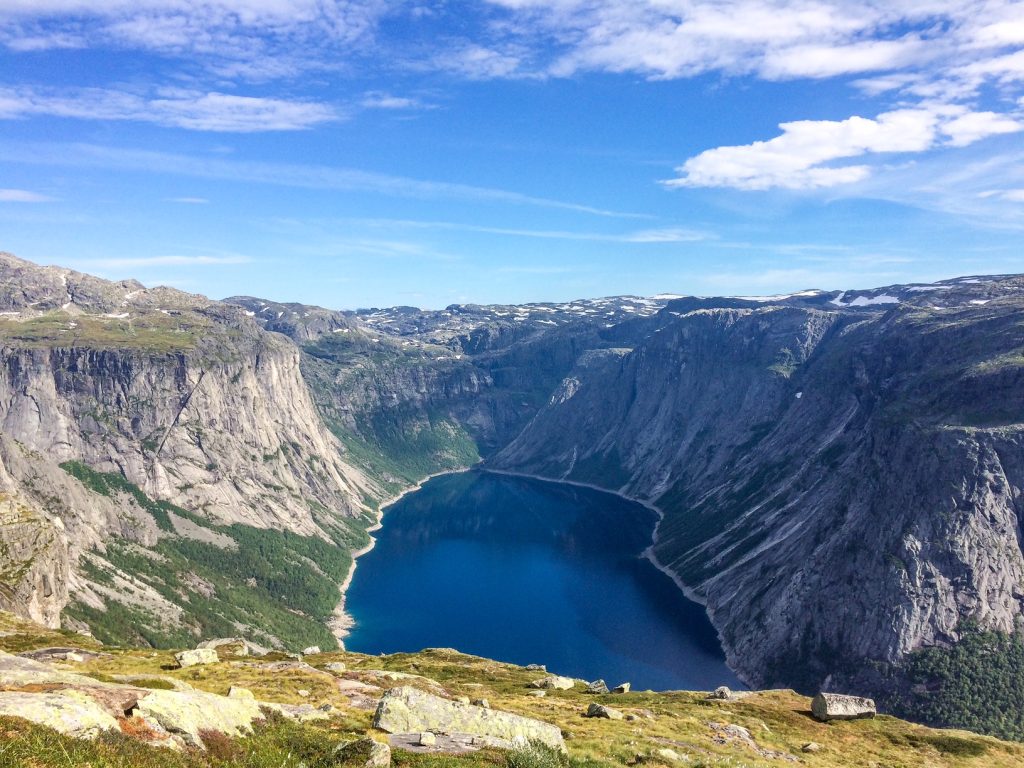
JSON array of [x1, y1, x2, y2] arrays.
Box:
[[0, 142, 648, 218]]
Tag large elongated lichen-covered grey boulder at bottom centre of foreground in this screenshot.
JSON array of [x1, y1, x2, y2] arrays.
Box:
[[374, 687, 565, 750]]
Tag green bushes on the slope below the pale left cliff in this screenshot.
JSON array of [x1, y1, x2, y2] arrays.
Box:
[[61, 462, 368, 650]]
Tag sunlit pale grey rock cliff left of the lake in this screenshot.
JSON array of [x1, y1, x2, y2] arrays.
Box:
[[0, 256, 382, 641]]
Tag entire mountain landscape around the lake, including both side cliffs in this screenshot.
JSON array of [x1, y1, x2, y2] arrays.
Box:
[[0, 256, 1024, 737]]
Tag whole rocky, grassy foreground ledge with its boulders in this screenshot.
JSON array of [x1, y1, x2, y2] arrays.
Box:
[[0, 613, 1024, 768]]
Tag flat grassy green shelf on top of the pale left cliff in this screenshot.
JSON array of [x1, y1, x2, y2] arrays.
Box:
[[0, 310, 211, 353]]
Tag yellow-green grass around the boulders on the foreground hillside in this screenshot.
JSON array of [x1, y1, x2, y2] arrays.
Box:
[[0, 614, 1024, 768]]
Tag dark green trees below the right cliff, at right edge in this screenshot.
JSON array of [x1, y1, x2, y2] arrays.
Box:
[[888, 626, 1024, 741]]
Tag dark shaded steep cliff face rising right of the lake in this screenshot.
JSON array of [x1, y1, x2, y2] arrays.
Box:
[[493, 287, 1024, 688]]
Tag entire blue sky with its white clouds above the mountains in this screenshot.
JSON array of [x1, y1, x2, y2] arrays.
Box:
[[0, 0, 1024, 308]]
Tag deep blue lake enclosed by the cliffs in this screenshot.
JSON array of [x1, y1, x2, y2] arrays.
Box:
[[345, 471, 742, 690]]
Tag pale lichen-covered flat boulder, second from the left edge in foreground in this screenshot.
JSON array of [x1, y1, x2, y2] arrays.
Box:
[[132, 690, 263, 749]]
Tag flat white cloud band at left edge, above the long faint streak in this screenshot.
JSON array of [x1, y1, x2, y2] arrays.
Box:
[[0, 88, 340, 133]]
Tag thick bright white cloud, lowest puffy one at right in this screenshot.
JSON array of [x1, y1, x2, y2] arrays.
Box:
[[665, 105, 1024, 189]]
